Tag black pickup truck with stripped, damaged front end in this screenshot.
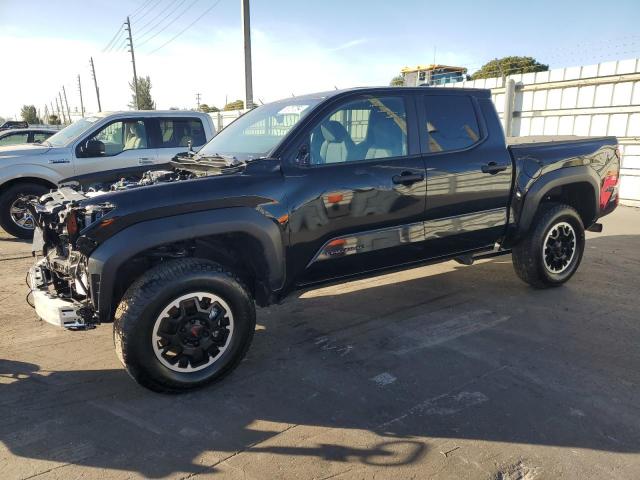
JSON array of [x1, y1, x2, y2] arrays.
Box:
[[29, 87, 620, 391]]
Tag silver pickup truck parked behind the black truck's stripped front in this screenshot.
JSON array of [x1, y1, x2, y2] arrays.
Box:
[[0, 110, 215, 238]]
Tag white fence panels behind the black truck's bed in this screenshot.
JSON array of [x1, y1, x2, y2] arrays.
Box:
[[436, 58, 640, 206]]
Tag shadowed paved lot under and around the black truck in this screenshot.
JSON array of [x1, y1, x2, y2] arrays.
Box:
[[0, 207, 640, 480]]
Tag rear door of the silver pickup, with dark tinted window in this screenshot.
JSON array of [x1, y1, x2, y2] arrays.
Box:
[[149, 117, 207, 164]]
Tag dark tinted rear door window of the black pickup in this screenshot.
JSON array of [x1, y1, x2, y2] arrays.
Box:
[[420, 95, 481, 153]]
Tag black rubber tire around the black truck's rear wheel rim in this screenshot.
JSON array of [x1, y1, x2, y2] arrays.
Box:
[[512, 203, 585, 288]]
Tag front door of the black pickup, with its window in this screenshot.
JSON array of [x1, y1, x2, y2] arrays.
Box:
[[285, 94, 426, 285]]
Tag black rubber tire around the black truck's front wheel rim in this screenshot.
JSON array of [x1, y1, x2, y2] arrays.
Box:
[[113, 258, 256, 393]]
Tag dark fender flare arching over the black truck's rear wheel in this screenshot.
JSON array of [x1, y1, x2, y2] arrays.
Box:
[[517, 165, 600, 236]]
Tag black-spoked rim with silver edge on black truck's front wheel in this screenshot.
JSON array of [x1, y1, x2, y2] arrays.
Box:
[[151, 292, 234, 373]]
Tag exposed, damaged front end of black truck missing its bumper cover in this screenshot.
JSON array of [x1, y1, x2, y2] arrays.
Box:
[[28, 187, 114, 329]]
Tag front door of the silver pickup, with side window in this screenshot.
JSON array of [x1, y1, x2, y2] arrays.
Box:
[[75, 118, 158, 183]]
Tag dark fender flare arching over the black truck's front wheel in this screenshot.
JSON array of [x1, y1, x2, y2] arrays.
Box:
[[87, 207, 285, 321]]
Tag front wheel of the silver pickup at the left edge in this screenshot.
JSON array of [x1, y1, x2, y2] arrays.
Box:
[[0, 183, 49, 239]]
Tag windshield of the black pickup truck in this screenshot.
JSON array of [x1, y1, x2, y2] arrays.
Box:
[[199, 98, 322, 160]]
